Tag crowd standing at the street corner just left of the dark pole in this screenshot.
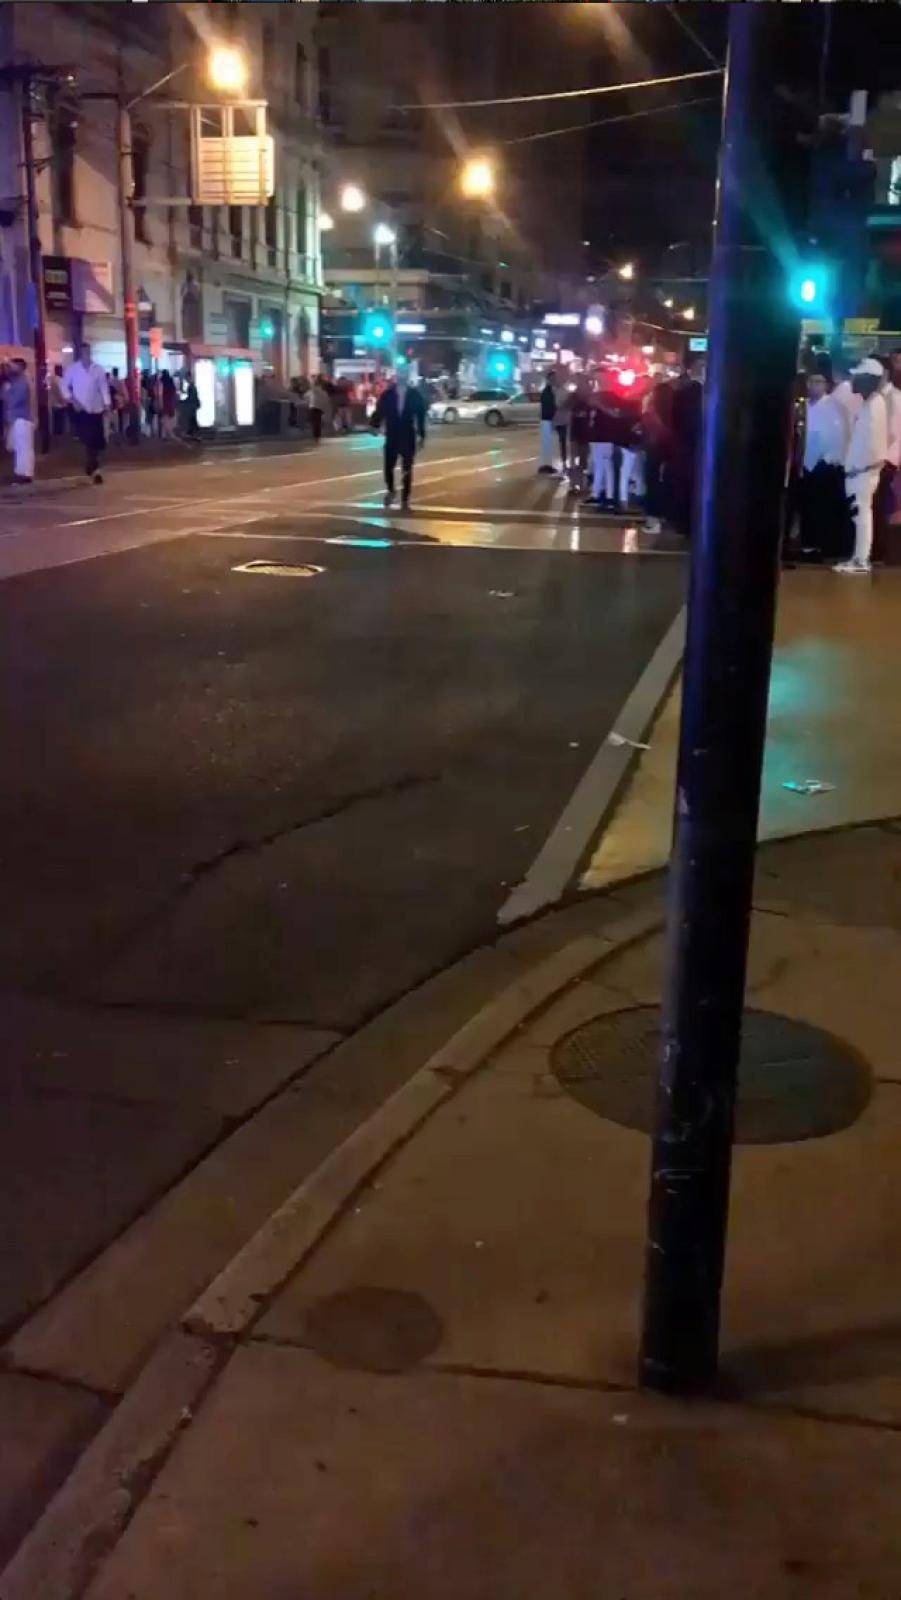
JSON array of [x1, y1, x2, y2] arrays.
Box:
[[538, 354, 706, 538]]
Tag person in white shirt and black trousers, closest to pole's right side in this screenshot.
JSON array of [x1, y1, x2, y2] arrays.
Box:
[[799, 373, 855, 562]]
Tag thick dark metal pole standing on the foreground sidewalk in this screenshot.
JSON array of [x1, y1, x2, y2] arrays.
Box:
[[640, 5, 799, 1394]]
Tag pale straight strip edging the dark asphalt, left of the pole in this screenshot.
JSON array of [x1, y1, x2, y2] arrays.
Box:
[[498, 606, 685, 923]]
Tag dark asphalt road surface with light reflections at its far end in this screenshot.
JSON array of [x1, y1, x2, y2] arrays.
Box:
[[0, 429, 685, 1325]]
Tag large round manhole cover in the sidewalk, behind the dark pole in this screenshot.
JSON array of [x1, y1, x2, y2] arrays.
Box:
[[552, 1006, 872, 1144]]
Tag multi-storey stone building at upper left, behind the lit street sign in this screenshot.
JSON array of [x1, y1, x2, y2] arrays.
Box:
[[0, 0, 323, 393]]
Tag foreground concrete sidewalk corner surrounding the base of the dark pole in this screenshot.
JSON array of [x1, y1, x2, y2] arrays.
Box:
[[12, 821, 901, 1600]]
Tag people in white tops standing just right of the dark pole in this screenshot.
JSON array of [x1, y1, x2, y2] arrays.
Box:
[[789, 349, 901, 576]]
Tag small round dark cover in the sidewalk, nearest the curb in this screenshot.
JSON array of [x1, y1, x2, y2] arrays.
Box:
[[304, 1288, 443, 1373]]
